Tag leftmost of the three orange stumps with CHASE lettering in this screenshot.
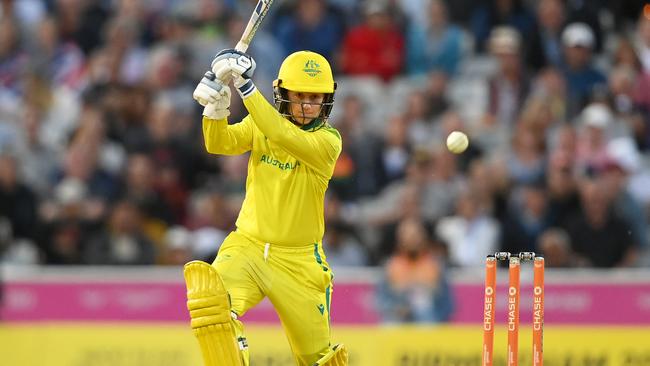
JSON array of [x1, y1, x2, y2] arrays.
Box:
[[482, 256, 497, 366]]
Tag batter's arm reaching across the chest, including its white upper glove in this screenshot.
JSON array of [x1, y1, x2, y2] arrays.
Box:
[[212, 50, 341, 176]]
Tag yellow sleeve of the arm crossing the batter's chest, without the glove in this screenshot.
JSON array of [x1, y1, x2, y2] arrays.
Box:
[[238, 90, 341, 174]]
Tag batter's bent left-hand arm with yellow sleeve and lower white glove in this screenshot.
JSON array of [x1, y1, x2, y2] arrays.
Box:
[[193, 72, 253, 155]]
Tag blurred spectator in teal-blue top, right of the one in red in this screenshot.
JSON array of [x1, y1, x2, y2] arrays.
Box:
[[406, 0, 464, 76]]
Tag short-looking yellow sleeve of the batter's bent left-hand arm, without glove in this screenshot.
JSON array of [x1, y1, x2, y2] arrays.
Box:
[[203, 116, 253, 155]]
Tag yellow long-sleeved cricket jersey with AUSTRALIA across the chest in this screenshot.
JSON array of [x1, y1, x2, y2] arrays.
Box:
[[203, 89, 341, 246]]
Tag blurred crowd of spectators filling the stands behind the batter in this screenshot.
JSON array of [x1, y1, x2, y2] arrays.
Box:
[[0, 0, 650, 320]]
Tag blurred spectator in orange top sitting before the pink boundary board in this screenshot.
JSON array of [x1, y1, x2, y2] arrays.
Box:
[[378, 218, 453, 323]]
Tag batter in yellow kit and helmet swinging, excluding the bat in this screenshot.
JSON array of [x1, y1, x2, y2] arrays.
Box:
[[184, 49, 348, 366]]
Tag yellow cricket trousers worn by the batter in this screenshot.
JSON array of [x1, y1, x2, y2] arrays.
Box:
[[212, 232, 334, 366]]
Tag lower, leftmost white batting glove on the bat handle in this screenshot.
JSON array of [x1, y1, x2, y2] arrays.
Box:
[[192, 71, 231, 119]]
